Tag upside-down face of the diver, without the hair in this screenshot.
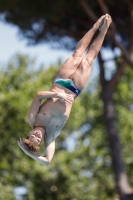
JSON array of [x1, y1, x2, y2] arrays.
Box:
[[28, 127, 44, 145]]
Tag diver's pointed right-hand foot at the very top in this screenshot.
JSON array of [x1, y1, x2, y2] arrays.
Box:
[[99, 14, 112, 32]]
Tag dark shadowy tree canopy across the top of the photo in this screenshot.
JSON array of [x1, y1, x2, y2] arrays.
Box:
[[0, 0, 131, 49]]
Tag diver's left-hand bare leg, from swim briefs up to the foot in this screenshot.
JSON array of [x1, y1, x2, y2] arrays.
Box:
[[55, 15, 105, 79]]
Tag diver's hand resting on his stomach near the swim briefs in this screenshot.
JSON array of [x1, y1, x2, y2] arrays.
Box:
[[57, 92, 74, 103]]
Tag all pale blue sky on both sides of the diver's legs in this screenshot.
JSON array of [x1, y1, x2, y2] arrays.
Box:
[[0, 21, 119, 81]]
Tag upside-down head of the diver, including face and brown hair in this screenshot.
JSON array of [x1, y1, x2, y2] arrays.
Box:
[[23, 126, 45, 152]]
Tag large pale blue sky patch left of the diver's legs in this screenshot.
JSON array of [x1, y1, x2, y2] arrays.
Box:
[[0, 21, 72, 66]]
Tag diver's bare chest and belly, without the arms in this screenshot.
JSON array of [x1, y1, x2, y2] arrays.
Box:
[[35, 83, 76, 145]]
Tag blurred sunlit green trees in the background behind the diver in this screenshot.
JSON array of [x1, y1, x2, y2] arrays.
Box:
[[0, 55, 133, 200]]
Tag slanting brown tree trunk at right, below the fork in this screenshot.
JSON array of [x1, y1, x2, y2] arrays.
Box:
[[102, 85, 133, 200]]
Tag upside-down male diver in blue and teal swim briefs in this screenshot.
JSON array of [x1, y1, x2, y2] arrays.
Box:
[[18, 14, 112, 165]]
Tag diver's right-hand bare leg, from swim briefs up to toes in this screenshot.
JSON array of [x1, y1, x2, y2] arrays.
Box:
[[72, 14, 112, 90]]
